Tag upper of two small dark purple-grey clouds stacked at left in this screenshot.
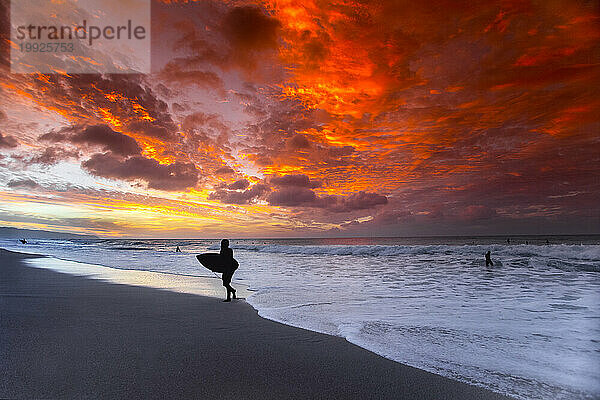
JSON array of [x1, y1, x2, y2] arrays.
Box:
[[40, 125, 142, 156]]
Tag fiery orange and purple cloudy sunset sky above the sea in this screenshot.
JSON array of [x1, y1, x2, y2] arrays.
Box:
[[0, 0, 600, 238]]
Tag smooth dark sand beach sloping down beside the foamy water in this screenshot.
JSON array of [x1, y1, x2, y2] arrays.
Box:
[[0, 250, 505, 399]]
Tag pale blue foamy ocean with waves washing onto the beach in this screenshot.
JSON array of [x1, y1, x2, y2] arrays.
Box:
[[0, 236, 600, 399]]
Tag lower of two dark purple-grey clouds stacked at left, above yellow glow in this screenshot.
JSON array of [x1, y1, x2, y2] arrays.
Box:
[[81, 153, 198, 191]]
